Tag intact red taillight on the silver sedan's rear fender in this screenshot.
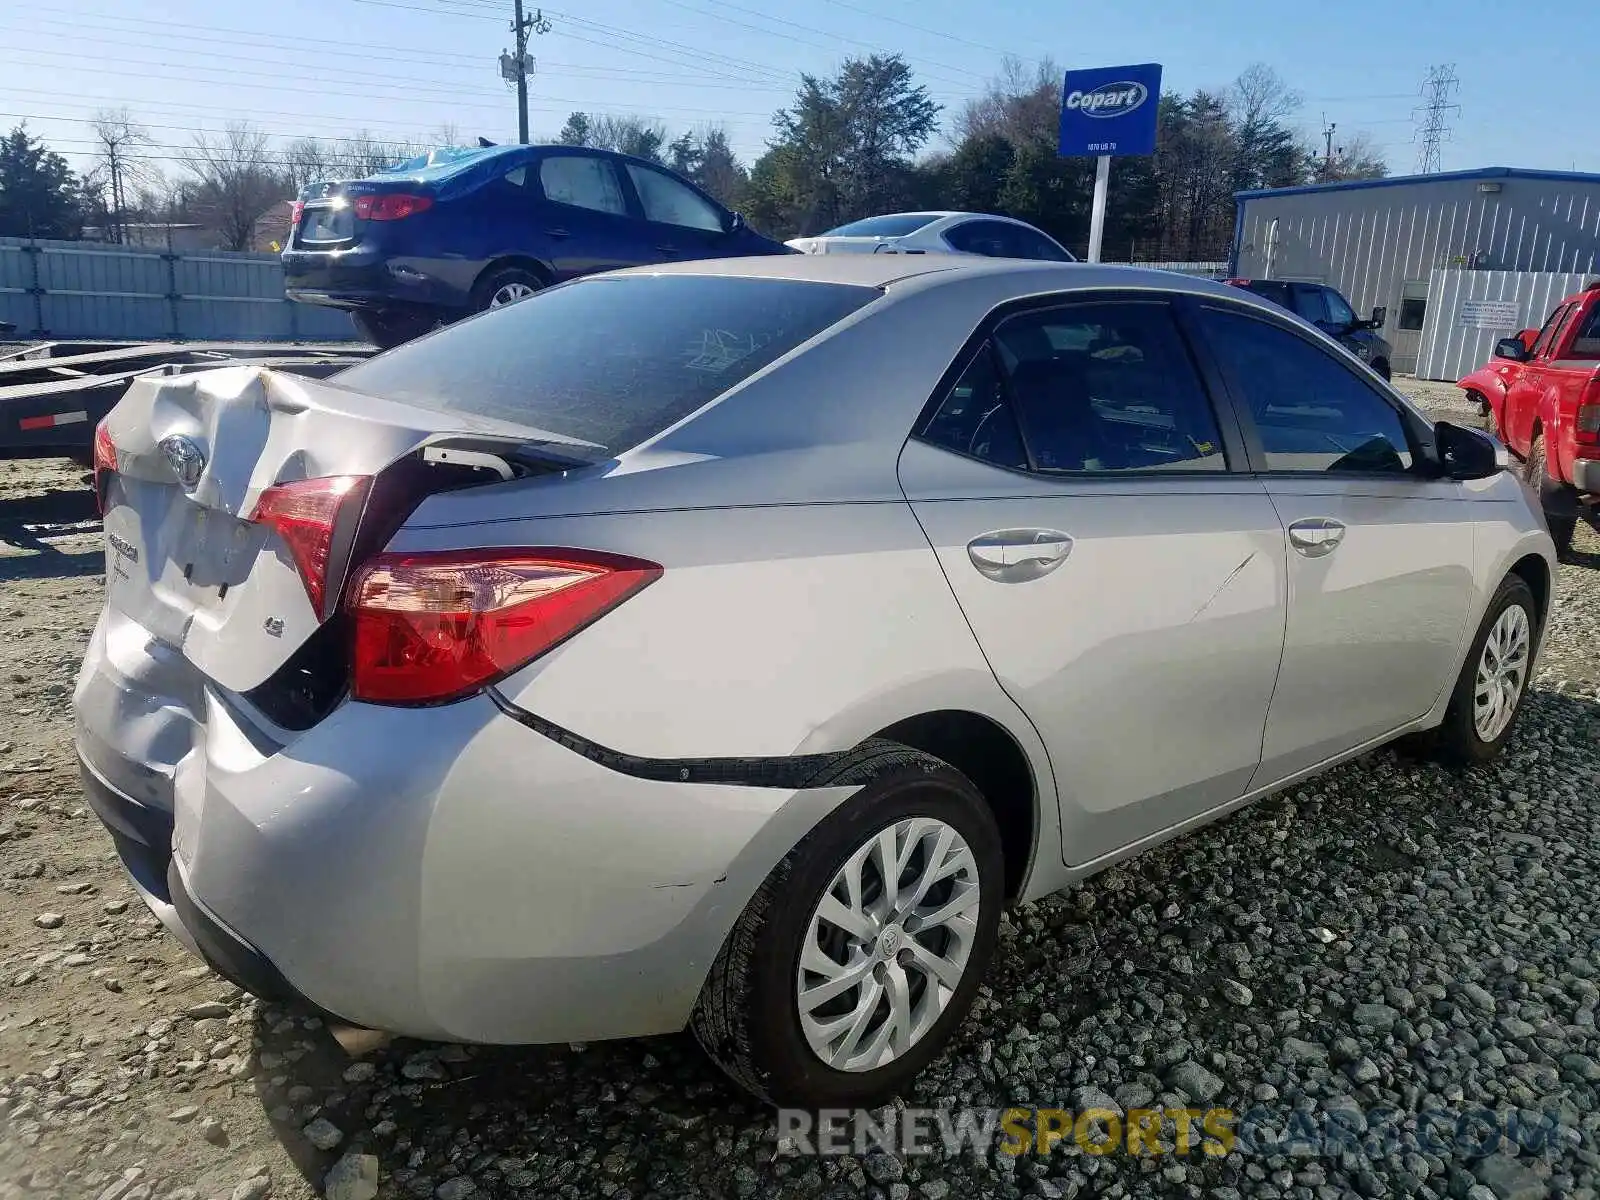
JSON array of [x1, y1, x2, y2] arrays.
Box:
[[347, 549, 661, 704]]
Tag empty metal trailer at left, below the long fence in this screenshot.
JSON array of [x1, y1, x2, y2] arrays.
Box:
[[0, 342, 373, 459]]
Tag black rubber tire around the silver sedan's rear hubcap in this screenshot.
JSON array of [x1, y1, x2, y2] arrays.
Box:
[[690, 741, 1005, 1109]]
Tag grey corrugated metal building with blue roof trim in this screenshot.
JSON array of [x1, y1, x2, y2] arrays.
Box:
[[1229, 166, 1600, 371]]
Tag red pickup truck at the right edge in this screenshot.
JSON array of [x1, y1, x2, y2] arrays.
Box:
[[1456, 280, 1600, 555]]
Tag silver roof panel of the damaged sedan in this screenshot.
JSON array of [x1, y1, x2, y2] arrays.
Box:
[[611, 254, 1254, 312]]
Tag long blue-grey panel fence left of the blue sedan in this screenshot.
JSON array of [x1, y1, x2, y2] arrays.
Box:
[[0, 237, 355, 341]]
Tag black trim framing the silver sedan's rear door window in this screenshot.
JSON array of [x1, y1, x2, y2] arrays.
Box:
[[907, 288, 1254, 483]]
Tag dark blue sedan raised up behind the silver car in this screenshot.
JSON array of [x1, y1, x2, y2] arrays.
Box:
[[283, 146, 794, 349]]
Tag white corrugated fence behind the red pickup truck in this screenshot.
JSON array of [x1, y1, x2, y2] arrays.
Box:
[[1416, 267, 1594, 379]]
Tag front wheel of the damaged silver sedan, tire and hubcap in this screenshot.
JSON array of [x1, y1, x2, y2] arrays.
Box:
[[1427, 574, 1539, 766]]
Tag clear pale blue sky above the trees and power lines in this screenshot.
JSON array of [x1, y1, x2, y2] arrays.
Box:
[[0, 0, 1600, 183]]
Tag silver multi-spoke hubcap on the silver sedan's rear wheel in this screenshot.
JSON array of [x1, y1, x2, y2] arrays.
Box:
[[795, 818, 981, 1070]]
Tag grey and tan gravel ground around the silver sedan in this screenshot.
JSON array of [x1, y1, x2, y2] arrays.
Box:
[[0, 384, 1600, 1200]]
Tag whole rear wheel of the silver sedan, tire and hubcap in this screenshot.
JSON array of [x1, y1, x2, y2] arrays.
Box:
[[691, 741, 1003, 1109]]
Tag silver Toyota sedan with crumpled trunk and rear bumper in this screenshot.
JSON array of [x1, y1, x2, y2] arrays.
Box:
[[75, 254, 1554, 1107]]
